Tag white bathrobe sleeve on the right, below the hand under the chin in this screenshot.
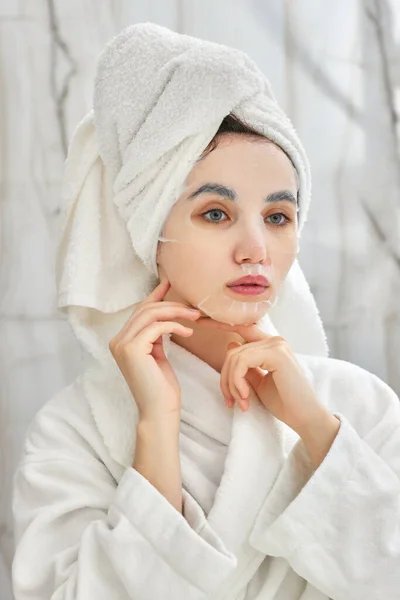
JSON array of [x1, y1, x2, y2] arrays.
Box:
[[250, 360, 400, 600]]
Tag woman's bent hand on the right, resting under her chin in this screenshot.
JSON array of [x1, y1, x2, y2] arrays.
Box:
[[196, 321, 327, 432]]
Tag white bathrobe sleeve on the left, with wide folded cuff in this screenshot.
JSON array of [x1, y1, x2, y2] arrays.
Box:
[[12, 400, 236, 600]]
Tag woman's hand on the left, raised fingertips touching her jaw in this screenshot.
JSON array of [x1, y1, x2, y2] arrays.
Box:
[[109, 278, 201, 422]]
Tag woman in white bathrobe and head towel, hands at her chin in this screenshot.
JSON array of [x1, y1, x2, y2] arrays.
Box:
[[13, 24, 400, 600]]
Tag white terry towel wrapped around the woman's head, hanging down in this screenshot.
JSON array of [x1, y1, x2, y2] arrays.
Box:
[[57, 23, 328, 362]]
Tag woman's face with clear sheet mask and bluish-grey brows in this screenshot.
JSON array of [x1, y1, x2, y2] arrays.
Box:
[[157, 134, 298, 324]]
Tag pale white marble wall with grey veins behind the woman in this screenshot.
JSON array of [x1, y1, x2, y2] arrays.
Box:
[[0, 0, 400, 600]]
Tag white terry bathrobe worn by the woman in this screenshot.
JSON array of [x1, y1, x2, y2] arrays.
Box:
[[12, 342, 400, 600]]
